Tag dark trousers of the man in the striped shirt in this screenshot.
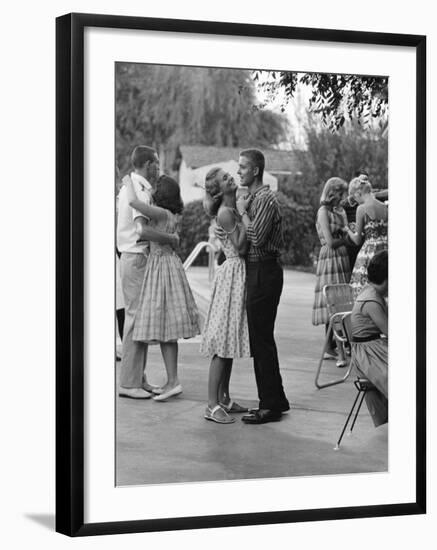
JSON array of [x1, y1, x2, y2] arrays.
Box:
[[246, 260, 289, 411]]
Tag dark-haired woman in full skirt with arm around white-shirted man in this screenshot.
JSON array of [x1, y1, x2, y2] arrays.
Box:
[[125, 176, 200, 401]]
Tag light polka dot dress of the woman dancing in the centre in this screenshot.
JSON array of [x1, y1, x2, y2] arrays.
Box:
[[200, 238, 250, 359]]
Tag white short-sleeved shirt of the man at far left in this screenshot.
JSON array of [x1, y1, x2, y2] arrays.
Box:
[[117, 172, 152, 253]]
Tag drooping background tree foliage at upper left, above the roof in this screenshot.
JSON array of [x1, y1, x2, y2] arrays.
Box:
[[115, 63, 287, 174]]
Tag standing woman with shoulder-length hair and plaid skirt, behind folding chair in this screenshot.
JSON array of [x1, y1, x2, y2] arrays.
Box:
[[312, 177, 350, 366]]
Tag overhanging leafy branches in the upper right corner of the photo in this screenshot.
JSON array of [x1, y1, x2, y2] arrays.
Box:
[[253, 71, 388, 132]]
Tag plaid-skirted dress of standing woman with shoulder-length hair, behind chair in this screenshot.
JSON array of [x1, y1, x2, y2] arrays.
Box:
[[312, 207, 351, 325]]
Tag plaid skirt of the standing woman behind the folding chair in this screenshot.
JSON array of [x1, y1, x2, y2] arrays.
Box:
[[312, 244, 351, 325]]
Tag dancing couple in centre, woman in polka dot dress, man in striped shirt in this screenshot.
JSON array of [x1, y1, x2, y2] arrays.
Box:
[[201, 149, 290, 424]]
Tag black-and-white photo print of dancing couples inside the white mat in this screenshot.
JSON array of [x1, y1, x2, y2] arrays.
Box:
[[114, 61, 390, 487]]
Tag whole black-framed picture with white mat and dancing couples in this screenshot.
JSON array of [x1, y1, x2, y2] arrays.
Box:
[[52, 14, 426, 536]]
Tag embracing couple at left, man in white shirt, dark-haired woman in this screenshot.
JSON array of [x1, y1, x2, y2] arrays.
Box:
[[117, 146, 200, 401]]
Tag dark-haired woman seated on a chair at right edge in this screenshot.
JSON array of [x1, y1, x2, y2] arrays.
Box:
[[351, 250, 388, 426]]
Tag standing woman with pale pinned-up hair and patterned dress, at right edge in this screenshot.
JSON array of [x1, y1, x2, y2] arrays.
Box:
[[344, 176, 388, 298]]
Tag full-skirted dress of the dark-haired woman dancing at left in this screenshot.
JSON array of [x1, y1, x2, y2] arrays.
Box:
[[133, 210, 200, 343]]
